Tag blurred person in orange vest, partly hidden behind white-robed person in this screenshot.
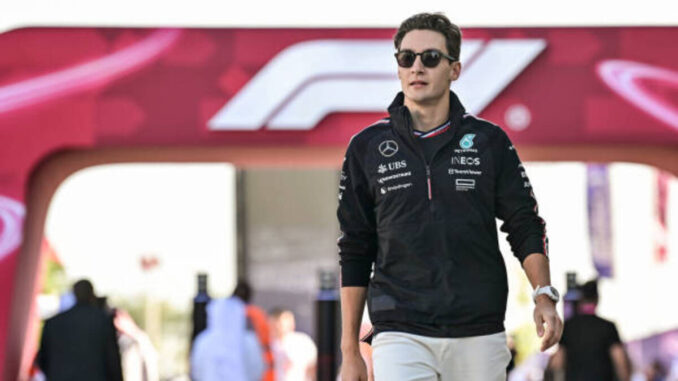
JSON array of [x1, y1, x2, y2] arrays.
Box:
[[233, 279, 275, 381]]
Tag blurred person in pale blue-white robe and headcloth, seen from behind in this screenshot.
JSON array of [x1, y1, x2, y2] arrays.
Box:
[[191, 297, 264, 381]]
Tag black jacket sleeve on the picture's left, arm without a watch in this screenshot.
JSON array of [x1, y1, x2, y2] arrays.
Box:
[[337, 140, 377, 287]]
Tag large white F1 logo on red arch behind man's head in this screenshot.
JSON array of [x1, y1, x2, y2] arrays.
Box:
[[207, 39, 546, 131]]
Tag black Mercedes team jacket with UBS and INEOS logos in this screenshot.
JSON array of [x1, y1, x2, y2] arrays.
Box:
[[337, 92, 547, 337]]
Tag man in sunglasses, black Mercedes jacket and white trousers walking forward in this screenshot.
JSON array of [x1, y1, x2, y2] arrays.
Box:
[[337, 13, 562, 381]]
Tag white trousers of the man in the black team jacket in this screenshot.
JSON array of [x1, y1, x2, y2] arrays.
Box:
[[372, 332, 511, 381]]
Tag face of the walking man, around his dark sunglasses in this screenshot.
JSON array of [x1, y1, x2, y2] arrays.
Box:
[[398, 29, 461, 105]]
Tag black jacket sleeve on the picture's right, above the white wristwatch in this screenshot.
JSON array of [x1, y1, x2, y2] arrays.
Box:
[[493, 130, 548, 263]]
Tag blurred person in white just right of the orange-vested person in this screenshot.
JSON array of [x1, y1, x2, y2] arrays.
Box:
[[270, 308, 318, 381]]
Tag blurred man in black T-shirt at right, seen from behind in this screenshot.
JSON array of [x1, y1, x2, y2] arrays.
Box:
[[550, 281, 631, 381]]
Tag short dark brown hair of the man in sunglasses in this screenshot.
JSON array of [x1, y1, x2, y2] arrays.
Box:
[[393, 13, 461, 60]]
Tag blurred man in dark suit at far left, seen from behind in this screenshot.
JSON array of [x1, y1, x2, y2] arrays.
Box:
[[36, 279, 122, 381]]
